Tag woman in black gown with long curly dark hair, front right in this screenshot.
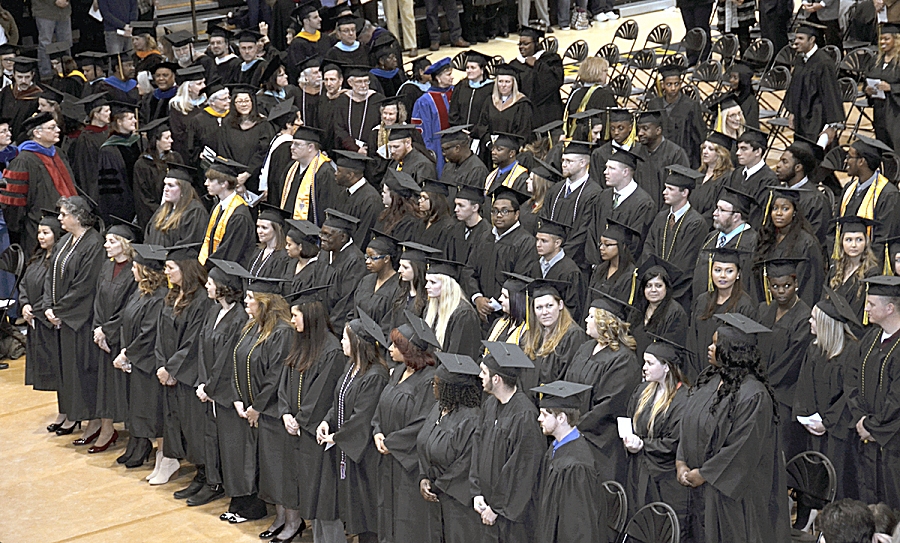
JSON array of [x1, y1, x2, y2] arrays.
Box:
[[675, 315, 790, 543]]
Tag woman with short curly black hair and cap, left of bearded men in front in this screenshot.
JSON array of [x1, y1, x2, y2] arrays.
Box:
[[416, 353, 487, 543]]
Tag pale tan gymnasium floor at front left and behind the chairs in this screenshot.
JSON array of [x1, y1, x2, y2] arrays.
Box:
[[0, 6, 860, 543]]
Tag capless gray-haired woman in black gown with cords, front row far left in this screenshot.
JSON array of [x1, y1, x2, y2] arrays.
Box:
[[40, 196, 104, 438]]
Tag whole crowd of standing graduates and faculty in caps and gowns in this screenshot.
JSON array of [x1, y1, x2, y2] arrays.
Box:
[[12, 3, 900, 543]]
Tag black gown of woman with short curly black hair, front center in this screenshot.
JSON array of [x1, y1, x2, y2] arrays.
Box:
[[416, 405, 486, 543]]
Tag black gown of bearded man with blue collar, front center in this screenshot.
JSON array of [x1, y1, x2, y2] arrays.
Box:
[[535, 435, 608, 543]]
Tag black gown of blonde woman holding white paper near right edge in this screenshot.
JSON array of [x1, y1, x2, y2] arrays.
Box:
[[791, 342, 859, 500]]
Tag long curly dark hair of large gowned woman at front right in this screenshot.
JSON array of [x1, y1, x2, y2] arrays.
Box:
[[697, 326, 779, 424]]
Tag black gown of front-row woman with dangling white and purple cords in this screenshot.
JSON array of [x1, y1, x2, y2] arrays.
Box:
[[319, 363, 389, 534]]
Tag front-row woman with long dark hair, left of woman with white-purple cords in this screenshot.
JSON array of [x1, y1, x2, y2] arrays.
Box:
[[282, 298, 347, 539]]
